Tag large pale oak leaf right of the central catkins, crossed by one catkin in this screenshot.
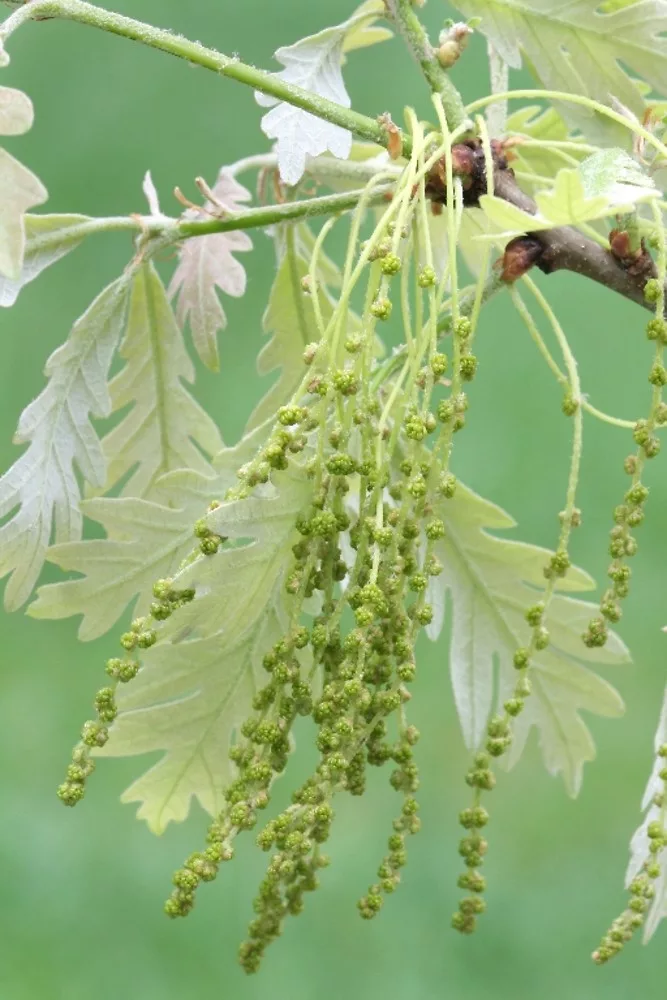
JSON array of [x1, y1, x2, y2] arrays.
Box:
[[428, 484, 629, 794]]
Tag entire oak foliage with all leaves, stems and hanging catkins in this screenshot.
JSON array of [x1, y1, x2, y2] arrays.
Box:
[[0, 0, 667, 972]]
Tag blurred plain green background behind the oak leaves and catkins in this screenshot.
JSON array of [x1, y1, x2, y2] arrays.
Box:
[[0, 0, 667, 1000]]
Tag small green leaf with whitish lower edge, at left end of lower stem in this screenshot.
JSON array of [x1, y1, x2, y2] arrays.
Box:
[[0, 215, 90, 306]]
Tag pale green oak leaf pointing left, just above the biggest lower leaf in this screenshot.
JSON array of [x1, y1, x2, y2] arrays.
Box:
[[28, 425, 270, 641]]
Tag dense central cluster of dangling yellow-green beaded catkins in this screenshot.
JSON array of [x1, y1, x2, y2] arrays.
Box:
[[59, 162, 477, 972]]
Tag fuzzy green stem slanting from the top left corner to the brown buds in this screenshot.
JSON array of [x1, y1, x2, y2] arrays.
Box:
[[0, 0, 411, 156]]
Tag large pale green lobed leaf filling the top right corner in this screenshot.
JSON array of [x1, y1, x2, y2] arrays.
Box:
[[455, 0, 667, 141]]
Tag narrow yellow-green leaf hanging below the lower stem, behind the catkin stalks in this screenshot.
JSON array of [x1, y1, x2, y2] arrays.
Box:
[[248, 251, 332, 430]]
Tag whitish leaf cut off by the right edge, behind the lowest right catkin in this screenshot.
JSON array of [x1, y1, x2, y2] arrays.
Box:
[[625, 688, 667, 944]]
